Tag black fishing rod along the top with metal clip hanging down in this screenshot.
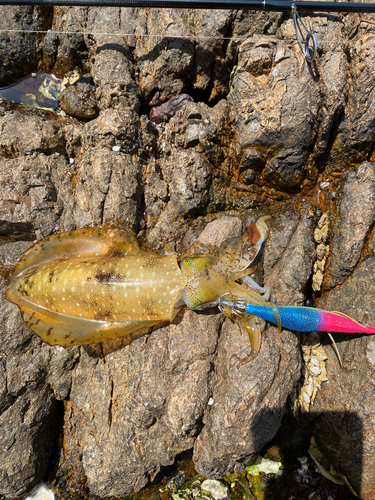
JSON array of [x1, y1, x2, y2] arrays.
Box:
[[0, 0, 375, 62]]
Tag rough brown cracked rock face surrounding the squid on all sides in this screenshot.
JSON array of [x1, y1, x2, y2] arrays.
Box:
[[0, 6, 375, 500]]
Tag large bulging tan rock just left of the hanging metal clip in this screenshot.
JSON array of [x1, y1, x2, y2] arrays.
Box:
[[228, 38, 318, 189]]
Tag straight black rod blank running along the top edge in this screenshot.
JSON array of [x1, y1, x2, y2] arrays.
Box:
[[0, 0, 375, 13]]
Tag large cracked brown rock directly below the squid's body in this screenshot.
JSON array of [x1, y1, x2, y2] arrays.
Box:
[[55, 312, 220, 497]]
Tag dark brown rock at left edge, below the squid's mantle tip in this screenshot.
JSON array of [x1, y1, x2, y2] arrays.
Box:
[[0, 242, 74, 498]]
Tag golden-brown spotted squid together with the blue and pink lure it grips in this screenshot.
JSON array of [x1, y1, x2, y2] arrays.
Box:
[[6, 217, 375, 361]]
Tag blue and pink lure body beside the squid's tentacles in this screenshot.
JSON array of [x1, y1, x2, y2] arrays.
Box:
[[245, 304, 375, 335]]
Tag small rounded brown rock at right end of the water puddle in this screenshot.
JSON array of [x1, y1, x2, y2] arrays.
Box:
[[59, 75, 99, 121]]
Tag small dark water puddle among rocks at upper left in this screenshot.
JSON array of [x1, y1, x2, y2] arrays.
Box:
[[0, 73, 61, 111]]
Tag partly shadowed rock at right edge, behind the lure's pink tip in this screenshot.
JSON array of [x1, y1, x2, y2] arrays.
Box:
[[312, 257, 375, 499]]
